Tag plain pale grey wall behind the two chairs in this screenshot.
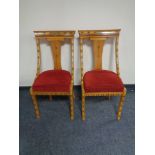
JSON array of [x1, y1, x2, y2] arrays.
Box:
[[19, 0, 135, 86]]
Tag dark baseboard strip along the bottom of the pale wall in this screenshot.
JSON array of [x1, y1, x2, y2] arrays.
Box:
[[19, 84, 135, 92]]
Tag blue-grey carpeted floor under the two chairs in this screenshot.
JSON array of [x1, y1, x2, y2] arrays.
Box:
[[19, 87, 135, 155]]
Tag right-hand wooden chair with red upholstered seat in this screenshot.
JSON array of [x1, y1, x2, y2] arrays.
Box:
[[79, 29, 126, 120]]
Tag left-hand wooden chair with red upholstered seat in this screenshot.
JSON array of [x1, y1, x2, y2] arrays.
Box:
[[30, 31, 75, 120]]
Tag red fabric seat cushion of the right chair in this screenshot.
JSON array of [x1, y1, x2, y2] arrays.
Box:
[[83, 70, 124, 92]]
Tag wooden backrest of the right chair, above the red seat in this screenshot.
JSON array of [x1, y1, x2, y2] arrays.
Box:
[[78, 29, 120, 79]]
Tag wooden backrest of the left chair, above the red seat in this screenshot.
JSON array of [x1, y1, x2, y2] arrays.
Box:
[[34, 31, 75, 78]]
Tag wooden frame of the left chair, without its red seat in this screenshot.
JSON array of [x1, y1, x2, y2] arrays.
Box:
[[30, 31, 75, 120]]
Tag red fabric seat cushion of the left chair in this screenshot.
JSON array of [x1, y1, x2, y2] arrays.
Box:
[[32, 70, 71, 92]]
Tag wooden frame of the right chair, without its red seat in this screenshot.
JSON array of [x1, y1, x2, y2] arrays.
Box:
[[78, 29, 126, 120]]
